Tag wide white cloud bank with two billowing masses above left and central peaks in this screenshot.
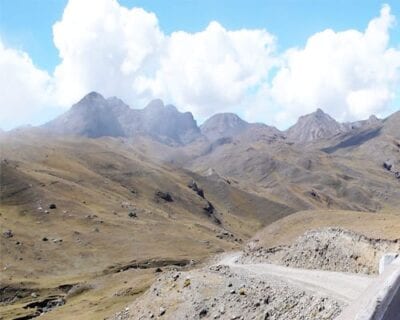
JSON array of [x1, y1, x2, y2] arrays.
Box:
[[53, 0, 275, 116]]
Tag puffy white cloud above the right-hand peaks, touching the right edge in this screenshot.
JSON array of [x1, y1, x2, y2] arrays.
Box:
[[271, 5, 400, 124]]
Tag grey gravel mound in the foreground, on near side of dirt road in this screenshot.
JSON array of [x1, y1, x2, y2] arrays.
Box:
[[111, 265, 344, 320]]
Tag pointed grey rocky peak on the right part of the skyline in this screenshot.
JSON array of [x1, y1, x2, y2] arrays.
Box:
[[287, 109, 346, 143]]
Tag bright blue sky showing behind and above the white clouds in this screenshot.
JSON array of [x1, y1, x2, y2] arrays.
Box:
[[0, 0, 400, 129]]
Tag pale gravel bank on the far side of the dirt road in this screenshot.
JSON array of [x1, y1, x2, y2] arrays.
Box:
[[238, 228, 400, 274]]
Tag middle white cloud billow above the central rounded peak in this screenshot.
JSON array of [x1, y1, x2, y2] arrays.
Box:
[[144, 22, 275, 117]]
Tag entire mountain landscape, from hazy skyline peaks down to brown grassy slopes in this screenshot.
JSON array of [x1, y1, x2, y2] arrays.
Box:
[[0, 92, 400, 319]]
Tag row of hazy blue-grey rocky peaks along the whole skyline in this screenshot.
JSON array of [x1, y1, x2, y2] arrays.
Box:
[[34, 92, 394, 145]]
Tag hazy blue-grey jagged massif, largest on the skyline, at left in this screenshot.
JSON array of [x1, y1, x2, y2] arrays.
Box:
[[43, 92, 200, 144]]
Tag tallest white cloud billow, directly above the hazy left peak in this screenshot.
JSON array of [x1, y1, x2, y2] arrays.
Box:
[[53, 0, 165, 104]]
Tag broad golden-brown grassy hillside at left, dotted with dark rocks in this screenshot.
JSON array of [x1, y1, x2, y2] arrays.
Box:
[[0, 134, 294, 317]]
